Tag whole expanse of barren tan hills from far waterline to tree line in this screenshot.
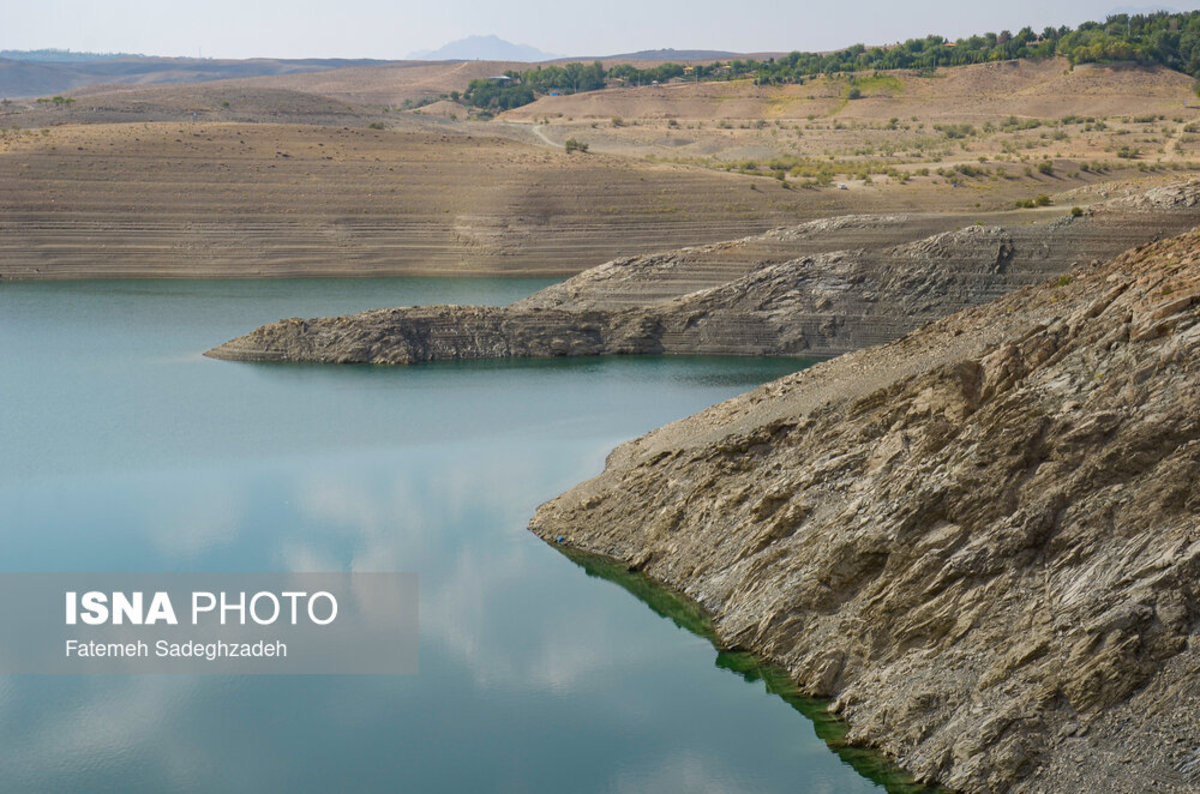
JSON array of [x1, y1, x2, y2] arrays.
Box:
[[0, 56, 1200, 278]]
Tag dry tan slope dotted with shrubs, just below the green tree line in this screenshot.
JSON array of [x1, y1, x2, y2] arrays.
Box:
[[503, 60, 1200, 197]]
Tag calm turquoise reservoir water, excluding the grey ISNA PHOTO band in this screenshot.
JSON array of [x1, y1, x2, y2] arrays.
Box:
[[0, 279, 916, 793]]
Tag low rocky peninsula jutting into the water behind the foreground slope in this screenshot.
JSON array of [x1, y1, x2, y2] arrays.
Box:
[[209, 182, 1200, 363]]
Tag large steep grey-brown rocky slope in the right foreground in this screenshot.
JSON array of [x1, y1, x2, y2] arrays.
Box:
[[530, 229, 1200, 793]]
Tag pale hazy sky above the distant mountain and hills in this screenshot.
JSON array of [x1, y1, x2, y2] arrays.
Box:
[[0, 0, 1200, 59]]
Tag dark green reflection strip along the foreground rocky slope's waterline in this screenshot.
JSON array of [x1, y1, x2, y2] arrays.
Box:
[[556, 547, 944, 794]]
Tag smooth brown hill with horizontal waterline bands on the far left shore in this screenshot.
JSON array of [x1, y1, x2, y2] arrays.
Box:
[[0, 118, 854, 278]]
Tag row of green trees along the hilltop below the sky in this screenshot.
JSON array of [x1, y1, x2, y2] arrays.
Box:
[[463, 11, 1200, 112]]
